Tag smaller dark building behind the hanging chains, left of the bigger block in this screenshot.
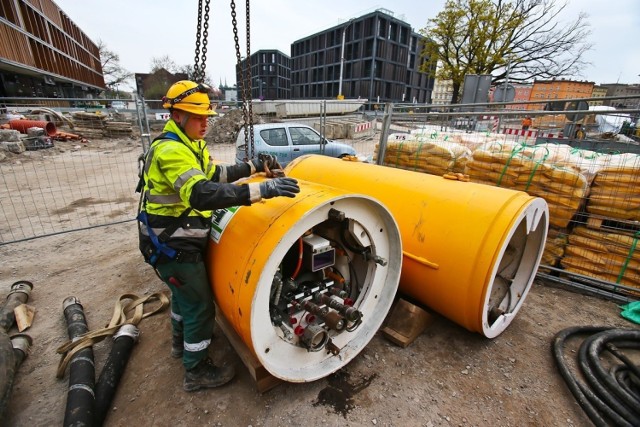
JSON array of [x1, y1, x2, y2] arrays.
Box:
[[236, 50, 291, 100]]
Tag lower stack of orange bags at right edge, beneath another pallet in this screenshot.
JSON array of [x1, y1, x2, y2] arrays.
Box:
[[561, 226, 640, 291]]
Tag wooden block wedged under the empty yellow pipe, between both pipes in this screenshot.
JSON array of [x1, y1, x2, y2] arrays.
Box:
[[381, 298, 433, 348]]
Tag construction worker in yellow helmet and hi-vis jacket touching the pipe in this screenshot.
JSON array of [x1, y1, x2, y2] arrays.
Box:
[[139, 80, 300, 391]]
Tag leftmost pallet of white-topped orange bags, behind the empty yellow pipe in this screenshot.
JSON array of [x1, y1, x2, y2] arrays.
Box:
[[374, 134, 471, 175]]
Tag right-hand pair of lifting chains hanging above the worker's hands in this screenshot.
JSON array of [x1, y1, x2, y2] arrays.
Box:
[[231, 0, 254, 159]]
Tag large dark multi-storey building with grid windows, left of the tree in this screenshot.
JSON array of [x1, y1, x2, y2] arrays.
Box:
[[291, 9, 434, 103]]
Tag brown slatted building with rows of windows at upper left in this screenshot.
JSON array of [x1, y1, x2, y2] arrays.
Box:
[[0, 0, 105, 98]]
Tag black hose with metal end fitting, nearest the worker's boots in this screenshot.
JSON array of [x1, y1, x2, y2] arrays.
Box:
[[95, 324, 140, 426]]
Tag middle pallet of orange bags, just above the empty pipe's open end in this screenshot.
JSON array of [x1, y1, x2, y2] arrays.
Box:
[[466, 141, 589, 229]]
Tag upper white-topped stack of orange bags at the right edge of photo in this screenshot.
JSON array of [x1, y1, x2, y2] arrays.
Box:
[[587, 153, 640, 221]]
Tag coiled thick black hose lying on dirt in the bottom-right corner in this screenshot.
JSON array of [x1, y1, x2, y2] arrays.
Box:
[[553, 326, 640, 427]]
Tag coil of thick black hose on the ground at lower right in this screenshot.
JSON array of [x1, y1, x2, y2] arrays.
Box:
[[553, 326, 640, 427]]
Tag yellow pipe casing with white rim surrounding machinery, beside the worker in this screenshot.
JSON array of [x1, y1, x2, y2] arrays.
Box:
[[207, 178, 402, 382]]
